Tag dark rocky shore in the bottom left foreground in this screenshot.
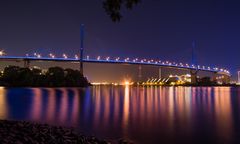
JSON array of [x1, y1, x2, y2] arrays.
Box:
[[0, 120, 132, 144]]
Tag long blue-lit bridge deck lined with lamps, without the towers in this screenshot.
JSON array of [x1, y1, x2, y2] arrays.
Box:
[[0, 54, 230, 76]]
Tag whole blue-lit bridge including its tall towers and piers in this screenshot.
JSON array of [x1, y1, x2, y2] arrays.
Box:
[[0, 24, 231, 83]]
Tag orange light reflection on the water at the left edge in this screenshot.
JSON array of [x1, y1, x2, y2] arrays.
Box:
[[0, 87, 8, 119]]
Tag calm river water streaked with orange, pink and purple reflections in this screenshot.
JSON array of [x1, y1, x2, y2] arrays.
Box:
[[0, 86, 240, 143]]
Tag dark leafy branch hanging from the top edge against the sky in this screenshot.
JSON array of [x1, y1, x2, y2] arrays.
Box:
[[103, 0, 140, 22]]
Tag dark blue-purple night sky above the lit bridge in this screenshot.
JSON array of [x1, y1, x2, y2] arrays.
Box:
[[0, 0, 240, 77]]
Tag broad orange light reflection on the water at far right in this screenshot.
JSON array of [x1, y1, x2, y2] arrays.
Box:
[[214, 87, 232, 140]]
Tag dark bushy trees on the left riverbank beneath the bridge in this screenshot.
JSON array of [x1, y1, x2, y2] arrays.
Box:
[[0, 66, 90, 87]]
